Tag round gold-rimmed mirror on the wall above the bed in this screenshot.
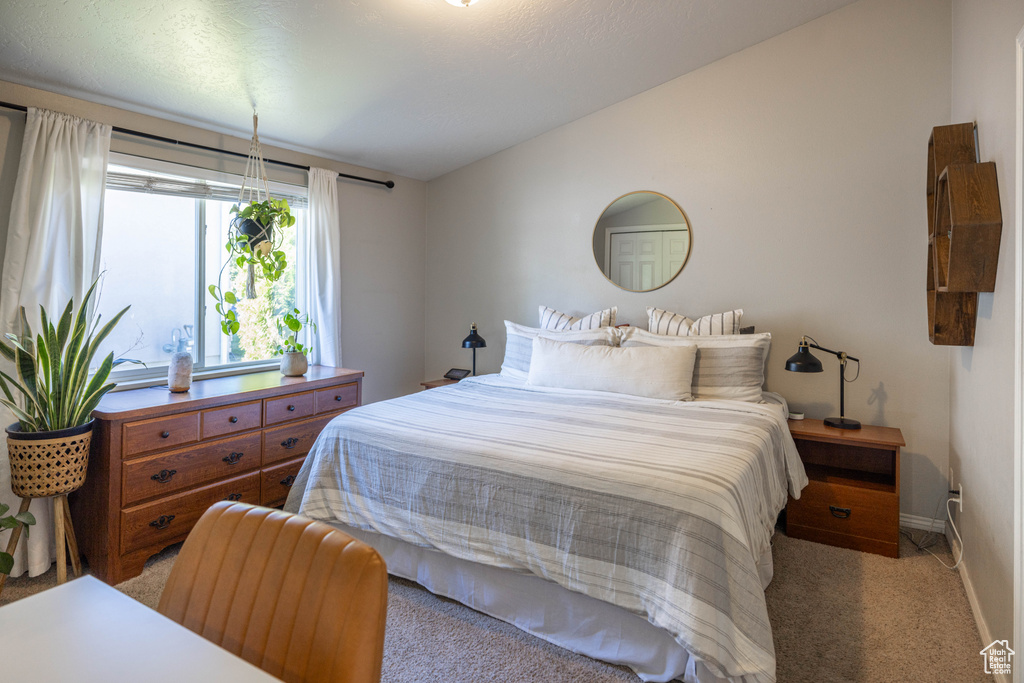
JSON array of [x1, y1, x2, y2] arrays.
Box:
[[594, 191, 691, 292]]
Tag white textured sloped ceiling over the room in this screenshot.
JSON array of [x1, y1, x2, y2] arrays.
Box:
[[0, 0, 851, 179]]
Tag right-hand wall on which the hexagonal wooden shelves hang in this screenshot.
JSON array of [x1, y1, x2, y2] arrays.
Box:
[[949, 0, 1024, 651]]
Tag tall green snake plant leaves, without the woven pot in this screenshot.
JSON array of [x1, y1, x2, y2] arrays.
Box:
[[0, 281, 134, 432]]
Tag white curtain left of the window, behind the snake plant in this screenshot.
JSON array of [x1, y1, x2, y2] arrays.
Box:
[[0, 109, 111, 577]]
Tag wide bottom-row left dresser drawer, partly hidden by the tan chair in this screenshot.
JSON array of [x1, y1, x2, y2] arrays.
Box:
[[121, 472, 260, 553]]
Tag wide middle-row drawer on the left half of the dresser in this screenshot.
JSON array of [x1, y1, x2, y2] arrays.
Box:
[[121, 432, 263, 506]]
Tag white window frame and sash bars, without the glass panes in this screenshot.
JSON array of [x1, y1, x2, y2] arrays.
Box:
[[100, 151, 309, 390]]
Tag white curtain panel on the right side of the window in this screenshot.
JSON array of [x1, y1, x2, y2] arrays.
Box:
[[296, 168, 342, 368]]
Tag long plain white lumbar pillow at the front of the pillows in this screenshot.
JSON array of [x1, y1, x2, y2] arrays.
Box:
[[526, 336, 697, 400]]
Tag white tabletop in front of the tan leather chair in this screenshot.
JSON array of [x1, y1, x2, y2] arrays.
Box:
[[0, 577, 278, 683]]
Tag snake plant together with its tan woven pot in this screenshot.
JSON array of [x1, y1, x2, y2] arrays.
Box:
[[0, 283, 134, 498]]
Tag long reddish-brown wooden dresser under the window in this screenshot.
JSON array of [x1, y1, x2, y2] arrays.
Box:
[[69, 366, 362, 585]]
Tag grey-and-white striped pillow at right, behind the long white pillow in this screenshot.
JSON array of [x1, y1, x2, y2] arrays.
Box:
[[621, 328, 771, 401]]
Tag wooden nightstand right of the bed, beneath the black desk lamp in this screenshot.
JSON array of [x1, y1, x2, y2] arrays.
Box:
[[785, 420, 906, 557]]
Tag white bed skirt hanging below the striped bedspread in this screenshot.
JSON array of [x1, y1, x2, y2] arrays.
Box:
[[323, 523, 772, 683]]
